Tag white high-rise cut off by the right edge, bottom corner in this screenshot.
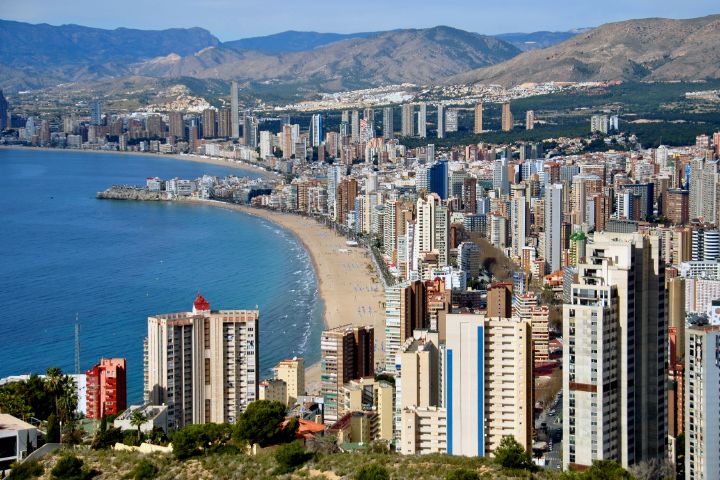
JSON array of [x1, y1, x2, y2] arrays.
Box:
[[684, 325, 720, 480]]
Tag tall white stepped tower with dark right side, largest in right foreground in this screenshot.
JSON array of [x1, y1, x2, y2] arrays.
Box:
[[563, 232, 668, 468]]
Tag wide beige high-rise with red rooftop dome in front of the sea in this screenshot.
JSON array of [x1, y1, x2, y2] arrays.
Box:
[[145, 294, 260, 429]]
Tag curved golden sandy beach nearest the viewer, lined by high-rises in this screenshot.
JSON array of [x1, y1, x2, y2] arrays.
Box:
[[178, 199, 385, 392]]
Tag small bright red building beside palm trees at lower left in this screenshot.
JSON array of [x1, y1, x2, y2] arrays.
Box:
[[85, 358, 127, 420]]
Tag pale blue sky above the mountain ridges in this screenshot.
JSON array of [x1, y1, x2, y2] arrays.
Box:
[[0, 0, 720, 41]]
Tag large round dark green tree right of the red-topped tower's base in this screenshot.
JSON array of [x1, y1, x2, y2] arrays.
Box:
[[235, 400, 287, 447]]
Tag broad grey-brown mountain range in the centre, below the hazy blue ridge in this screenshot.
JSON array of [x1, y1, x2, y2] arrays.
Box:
[[130, 27, 520, 90]]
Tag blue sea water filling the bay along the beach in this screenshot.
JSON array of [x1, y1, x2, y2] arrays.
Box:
[[0, 149, 322, 402]]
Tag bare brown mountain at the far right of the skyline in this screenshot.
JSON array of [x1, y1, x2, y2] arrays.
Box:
[[448, 15, 720, 85]]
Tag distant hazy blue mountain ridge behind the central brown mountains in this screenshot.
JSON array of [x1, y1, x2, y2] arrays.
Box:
[[223, 30, 377, 53]]
